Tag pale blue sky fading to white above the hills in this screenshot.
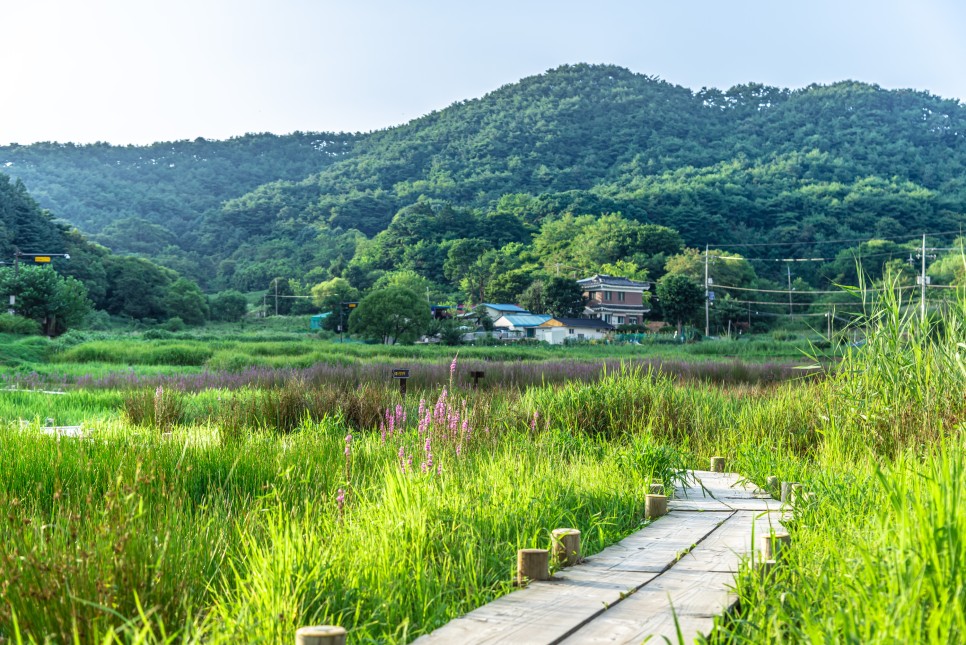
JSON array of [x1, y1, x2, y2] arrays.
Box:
[[0, 0, 966, 145]]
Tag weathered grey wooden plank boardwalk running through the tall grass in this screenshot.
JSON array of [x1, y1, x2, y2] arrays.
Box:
[[415, 471, 781, 645]]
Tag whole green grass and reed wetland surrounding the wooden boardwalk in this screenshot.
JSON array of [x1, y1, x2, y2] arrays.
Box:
[[0, 294, 966, 643]]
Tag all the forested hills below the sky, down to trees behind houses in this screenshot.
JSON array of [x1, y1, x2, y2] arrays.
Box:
[[0, 65, 966, 328]]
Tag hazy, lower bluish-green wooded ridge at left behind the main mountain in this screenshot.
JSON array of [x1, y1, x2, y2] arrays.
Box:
[[0, 133, 355, 277]]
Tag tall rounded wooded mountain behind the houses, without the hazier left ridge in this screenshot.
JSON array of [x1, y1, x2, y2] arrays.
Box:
[[0, 64, 966, 288]]
